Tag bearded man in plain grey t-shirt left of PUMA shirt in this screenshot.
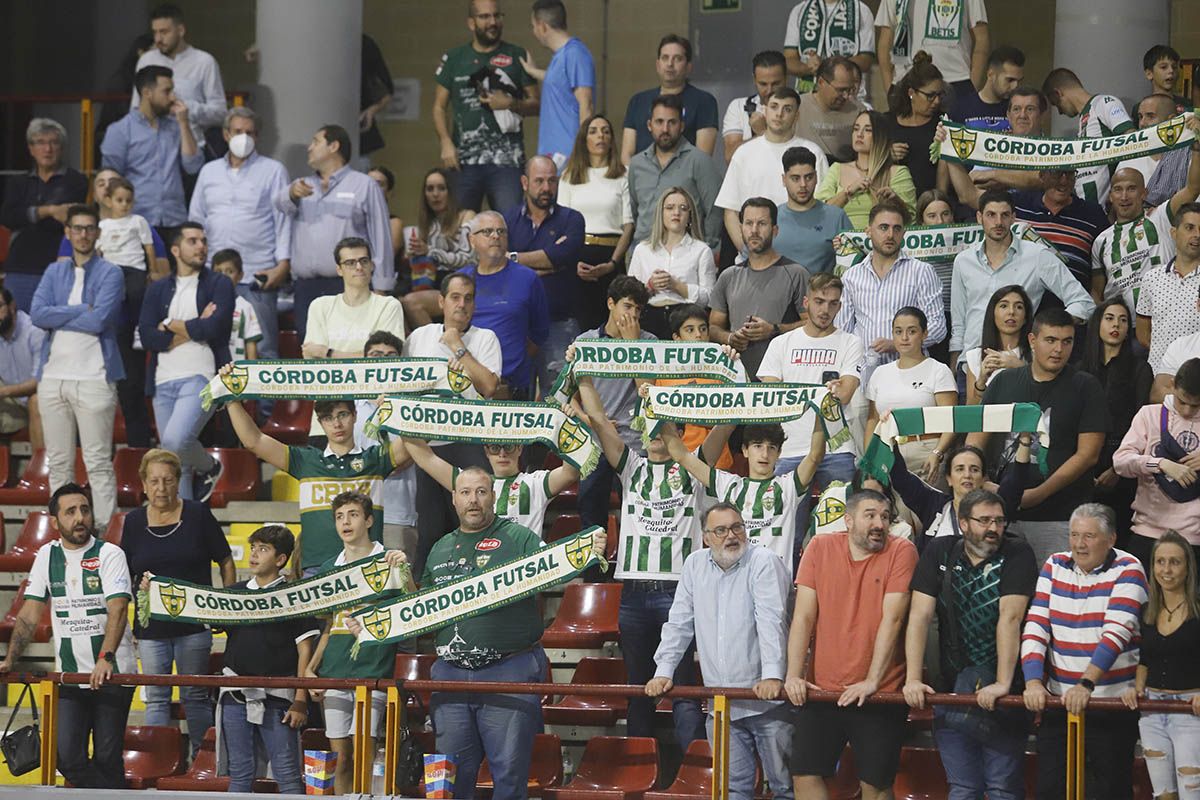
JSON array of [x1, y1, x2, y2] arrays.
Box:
[[708, 197, 809, 380]]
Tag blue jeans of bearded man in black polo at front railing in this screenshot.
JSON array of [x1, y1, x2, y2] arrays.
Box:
[[934, 705, 1026, 800]]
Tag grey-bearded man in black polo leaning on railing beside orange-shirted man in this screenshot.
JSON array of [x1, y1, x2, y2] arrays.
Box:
[[904, 489, 1038, 800]]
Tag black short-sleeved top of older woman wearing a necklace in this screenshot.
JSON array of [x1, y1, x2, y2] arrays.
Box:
[[121, 500, 233, 639]]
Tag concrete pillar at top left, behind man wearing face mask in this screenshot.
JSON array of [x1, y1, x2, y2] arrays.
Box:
[[252, 0, 362, 178]]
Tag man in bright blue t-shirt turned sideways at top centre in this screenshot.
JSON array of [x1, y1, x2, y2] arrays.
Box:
[[523, 0, 596, 169]]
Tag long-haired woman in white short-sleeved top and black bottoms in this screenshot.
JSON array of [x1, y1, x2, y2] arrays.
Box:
[[558, 114, 634, 331]]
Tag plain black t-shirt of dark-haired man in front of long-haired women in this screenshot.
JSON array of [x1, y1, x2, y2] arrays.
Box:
[[983, 365, 1110, 522]]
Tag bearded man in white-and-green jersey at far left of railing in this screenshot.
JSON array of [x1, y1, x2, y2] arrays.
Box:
[[0, 483, 137, 789]]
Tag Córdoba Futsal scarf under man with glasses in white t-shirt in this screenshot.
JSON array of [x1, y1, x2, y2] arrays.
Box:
[[200, 359, 470, 411]]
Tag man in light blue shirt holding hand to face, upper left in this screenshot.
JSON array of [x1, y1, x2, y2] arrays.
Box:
[[100, 66, 204, 227]]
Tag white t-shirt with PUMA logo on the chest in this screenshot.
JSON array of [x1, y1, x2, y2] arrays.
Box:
[[757, 326, 864, 458]]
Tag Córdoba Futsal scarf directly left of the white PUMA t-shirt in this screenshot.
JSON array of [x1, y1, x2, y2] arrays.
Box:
[[632, 383, 851, 450]]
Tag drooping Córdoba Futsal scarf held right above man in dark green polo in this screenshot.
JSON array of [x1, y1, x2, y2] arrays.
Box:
[[364, 397, 600, 477]]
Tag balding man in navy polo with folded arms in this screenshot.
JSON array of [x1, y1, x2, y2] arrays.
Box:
[[504, 156, 584, 393]]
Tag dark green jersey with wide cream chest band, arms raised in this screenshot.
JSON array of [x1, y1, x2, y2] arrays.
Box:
[[286, 445, 396, 569]]
